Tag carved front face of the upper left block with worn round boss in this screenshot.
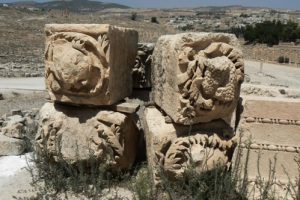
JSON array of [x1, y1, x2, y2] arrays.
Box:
[[45, 32, 109, 96]]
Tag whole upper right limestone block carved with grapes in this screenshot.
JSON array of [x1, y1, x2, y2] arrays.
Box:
[[152, 33, 244, 124]]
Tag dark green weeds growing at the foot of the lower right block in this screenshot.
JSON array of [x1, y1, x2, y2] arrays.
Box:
[[163, 167, 247, 200]]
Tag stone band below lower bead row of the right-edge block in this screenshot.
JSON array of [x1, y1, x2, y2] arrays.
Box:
[[240, 149, 300, 200]]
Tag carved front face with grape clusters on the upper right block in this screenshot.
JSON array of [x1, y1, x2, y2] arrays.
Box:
[[177, 42, 244, 123]]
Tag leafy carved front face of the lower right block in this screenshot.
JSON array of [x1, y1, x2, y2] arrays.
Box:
[[155, 134, 237, 180]]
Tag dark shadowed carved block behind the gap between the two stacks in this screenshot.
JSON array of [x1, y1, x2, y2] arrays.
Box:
[[132, 43, 154, 88]]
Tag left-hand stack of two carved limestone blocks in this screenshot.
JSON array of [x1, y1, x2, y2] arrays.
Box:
[[35, 24, 139, 170]]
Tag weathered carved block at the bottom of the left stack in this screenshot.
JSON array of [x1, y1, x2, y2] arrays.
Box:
[[36, 103, 139, 169]]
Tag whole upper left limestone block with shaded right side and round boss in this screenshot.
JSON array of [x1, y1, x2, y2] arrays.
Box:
[[45, 24, 138, 105]]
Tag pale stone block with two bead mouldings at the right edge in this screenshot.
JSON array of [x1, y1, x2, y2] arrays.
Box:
[[235, 99, 300, 199]]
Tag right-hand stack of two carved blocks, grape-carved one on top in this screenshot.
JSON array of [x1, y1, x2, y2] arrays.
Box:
[[144, 33, 244, 183]]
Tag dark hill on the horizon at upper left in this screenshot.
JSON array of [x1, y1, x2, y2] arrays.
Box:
[[8, 0, 129, 12]]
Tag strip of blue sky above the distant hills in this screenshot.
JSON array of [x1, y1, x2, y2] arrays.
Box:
[[0, 0, 300, 10]]
